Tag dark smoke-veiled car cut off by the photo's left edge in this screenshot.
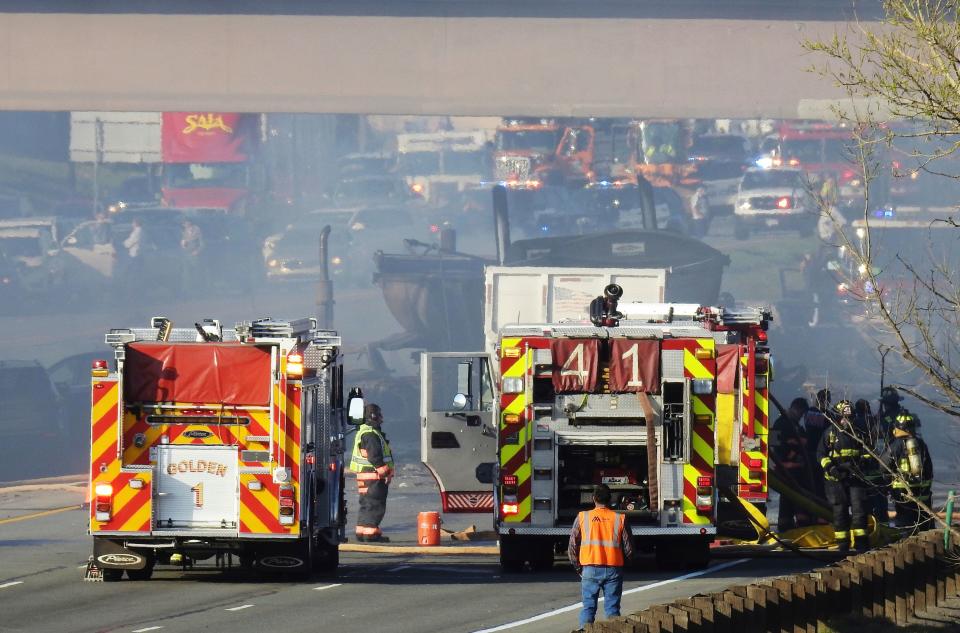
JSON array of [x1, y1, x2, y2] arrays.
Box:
[[0, 360, 68, 481]]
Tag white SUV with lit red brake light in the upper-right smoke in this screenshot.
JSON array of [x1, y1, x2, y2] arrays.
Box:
[[734, 168, 819, 239]]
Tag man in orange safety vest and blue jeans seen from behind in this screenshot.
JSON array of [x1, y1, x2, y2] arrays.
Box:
[[567, 484, 633, 629]]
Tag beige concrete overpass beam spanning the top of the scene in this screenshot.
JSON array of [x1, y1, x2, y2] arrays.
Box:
[[0, 0, 880, 118]]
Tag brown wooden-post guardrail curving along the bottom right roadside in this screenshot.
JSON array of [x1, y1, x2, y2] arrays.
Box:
[[586, 530, 960, 633]]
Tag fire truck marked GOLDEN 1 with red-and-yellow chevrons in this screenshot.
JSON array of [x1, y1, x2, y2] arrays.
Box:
[[87, 317, 346, 580]]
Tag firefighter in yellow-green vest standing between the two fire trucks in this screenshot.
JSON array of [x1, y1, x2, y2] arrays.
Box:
[[350, 404, 394, 543]]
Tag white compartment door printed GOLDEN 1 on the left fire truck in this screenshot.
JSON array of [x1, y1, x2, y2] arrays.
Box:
[[154, 444, 239, 534]]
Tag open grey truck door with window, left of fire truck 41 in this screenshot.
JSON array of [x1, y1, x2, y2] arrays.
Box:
[[420, 352, 497, 513]]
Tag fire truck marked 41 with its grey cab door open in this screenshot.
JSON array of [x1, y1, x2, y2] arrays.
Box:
[[421, 284, 771, 569]]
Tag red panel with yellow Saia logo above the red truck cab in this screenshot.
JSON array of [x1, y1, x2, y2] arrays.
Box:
[[161, 112, 256, 163]]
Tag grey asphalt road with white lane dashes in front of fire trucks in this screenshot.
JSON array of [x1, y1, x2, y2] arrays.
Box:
[[0, 476, 814, 633]]
